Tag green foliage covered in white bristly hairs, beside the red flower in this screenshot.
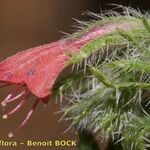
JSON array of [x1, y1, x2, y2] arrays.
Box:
[[55, 8, 150, 150]]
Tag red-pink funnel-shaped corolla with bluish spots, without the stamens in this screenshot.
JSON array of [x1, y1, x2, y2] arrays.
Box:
[[0, 22, 138, 99]]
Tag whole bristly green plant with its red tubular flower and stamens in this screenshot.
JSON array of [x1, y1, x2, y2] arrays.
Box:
[[0, 4, 150, 150]]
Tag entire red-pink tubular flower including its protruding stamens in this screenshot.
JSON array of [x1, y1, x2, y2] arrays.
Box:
[[0, 23, 136, 137]]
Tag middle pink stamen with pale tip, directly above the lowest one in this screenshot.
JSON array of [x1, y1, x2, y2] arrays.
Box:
[[2, 94, 30, 119]]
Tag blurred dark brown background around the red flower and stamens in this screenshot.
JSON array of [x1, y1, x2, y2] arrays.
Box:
[[0, 0, 149, 150]]
